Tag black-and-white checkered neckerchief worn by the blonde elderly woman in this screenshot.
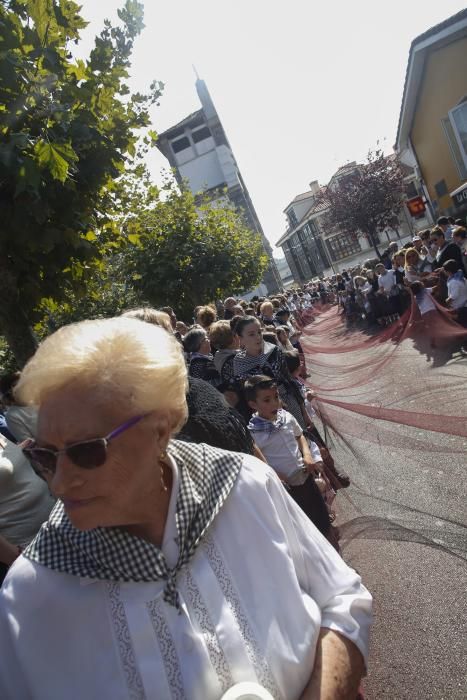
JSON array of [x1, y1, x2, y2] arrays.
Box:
[[23, 440, 243, 608]]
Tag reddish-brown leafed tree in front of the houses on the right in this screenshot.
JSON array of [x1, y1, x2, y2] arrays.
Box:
[[318, 149, 404, 257]]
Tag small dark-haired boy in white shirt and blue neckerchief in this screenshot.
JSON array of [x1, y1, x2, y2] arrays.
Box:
[[244, 375, 331, 537]]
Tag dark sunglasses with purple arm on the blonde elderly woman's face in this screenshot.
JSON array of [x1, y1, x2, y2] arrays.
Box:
[[23, 415, 144, 474]]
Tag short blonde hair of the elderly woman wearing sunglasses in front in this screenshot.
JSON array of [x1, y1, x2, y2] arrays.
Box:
[[15, 316, 187, 432]]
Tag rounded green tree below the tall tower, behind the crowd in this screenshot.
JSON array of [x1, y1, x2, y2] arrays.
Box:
[[124, 180, 267, 320]]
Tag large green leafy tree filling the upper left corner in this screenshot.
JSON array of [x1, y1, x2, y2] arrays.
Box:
[[0, 0, 162, 365]]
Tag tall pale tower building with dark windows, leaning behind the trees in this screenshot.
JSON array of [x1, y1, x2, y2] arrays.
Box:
[[157, 78, 282, 293]]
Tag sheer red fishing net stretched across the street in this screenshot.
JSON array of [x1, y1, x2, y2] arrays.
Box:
[[301, 297, 467, 452]]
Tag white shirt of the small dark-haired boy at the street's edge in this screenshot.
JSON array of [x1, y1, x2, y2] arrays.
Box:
[[252, 409, 321, 486]]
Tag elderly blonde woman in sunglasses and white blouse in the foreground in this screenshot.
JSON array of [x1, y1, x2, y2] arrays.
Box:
[[0, 318, 371, 700]]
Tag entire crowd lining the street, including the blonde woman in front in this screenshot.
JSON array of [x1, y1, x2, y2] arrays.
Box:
[[0, 219, 467, 700]]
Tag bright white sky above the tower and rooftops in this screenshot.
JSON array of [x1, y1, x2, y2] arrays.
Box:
[[78, 0, 465, 256]]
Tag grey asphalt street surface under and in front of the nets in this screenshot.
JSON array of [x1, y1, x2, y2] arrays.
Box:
[[308, 316, 467, 700]]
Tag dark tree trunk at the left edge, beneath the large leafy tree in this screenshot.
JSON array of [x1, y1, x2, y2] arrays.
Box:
[[0, 264, 37, 368]]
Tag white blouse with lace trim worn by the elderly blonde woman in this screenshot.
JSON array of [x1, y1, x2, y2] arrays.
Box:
[[0, 455, 371, 700]]
